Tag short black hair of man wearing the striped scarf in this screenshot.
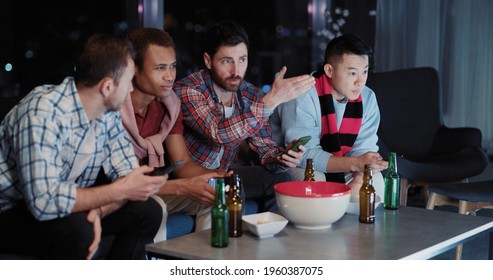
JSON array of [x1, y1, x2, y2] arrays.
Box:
[[324, 34, 373, 65]]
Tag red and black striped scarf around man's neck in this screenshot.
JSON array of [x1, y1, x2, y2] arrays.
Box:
[[315, 71, 363, 183]]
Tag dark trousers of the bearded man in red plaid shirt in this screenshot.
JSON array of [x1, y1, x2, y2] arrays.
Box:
[[231, 166, 291, 212]]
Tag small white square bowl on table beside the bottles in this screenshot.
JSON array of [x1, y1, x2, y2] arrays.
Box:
[[242, 212, 288, 238]]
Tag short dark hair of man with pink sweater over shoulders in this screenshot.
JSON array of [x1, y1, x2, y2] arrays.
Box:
[[127, 27, 175, 69]]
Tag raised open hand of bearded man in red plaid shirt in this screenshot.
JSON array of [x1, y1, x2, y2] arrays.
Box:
[[262, 66, 315, 110]]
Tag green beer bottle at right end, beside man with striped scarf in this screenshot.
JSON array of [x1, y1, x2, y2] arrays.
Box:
[[383, 152, 401, 210]]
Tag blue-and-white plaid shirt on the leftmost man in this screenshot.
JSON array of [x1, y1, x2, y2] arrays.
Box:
[[0, 77, 138, 220]]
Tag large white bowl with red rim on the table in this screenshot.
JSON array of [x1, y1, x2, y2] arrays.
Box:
[[274, 181, 351, 230]]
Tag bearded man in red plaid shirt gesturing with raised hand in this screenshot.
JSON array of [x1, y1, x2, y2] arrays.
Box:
[[174, 21, 314, 210]]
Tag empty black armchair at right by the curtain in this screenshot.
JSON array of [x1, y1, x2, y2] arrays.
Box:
[[367, 67, 488, 205]]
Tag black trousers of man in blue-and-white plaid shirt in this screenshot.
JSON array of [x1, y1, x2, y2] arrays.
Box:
[[0, 199, 162, 260]]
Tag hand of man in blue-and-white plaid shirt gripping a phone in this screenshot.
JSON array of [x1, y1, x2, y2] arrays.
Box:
[[115, 165, 168, 201]]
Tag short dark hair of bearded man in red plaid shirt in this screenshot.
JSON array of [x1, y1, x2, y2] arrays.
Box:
[[204, 20, 249, 57]]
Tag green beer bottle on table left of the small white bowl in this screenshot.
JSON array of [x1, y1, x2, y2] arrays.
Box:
[[211, 178, 229, 247]]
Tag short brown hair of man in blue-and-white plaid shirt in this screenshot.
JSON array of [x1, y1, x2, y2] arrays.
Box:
[[74, 33, 135, 87]]
